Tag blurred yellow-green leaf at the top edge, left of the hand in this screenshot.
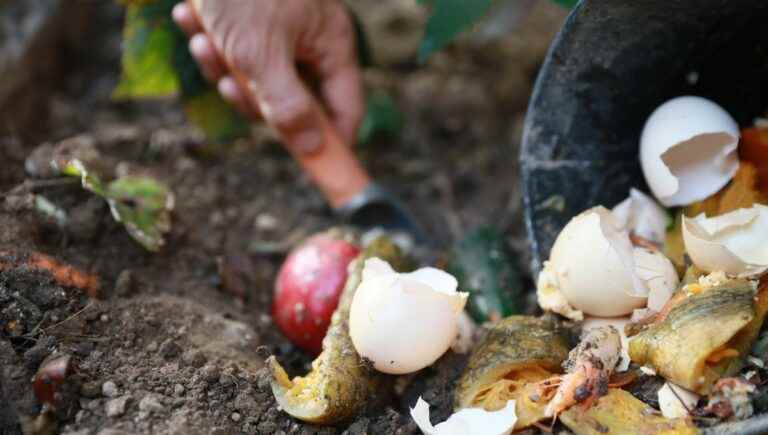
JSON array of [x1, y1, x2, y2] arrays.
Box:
[[113, 0, 180, 98]]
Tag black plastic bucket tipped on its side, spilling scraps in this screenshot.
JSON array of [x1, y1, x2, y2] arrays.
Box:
[[520, 0, 768, 434]]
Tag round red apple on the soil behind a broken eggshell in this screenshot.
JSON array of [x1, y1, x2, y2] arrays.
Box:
[[272, 232, 360, 354]]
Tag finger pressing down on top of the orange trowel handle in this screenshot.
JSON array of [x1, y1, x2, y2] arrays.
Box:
[[251, 64, 325, 153]]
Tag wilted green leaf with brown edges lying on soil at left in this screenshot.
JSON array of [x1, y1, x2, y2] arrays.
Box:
[[57, 159, 174, 252]]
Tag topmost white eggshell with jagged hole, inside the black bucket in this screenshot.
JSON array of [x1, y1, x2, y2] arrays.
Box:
[[640, 96, 740, 207]]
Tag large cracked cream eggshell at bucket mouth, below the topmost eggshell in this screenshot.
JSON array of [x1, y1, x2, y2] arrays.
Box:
[[537, 206, 677, 320]]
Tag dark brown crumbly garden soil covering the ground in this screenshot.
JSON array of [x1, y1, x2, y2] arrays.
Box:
[[0, 0, 565, 435]]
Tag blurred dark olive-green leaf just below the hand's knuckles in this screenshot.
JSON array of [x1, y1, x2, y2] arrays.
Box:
[[184, 89, 250, 143]]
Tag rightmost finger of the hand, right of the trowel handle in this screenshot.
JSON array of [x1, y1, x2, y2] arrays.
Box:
[[321, 62, 365, 145]]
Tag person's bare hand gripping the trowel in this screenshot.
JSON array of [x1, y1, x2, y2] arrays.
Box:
[[173, 0, 364, 153]]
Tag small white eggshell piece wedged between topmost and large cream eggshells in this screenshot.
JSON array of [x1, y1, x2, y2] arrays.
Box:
[[611, 188, 669, 245]]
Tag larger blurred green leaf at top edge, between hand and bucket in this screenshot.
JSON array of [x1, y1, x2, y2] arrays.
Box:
[[419, 0, 492, 62]]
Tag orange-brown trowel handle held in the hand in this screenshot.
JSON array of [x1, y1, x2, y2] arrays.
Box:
[[188, 0, 371, 210]]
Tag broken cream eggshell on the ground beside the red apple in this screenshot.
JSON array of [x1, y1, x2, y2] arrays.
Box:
[[349, 258, 468, 374]]
